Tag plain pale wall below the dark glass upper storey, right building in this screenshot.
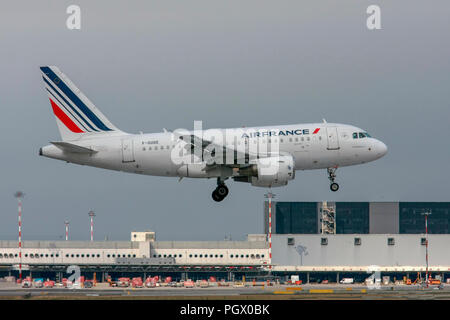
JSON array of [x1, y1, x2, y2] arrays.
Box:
[[272, 234, 450, 270]]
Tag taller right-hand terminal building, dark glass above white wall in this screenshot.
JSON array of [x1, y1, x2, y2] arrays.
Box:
[[264, 202, 450, 280]]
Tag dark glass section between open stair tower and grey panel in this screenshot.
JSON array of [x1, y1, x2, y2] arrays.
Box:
[[336, 202, 369, 234]]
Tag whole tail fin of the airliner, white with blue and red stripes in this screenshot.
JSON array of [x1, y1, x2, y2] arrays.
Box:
[[40, 66, 122, 141]]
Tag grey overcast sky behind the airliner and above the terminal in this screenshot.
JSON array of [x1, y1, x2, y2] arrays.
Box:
[[0, 0, 450, 240]]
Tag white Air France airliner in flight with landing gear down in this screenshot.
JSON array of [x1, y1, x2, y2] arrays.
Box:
[[39, 66, 387, 201]]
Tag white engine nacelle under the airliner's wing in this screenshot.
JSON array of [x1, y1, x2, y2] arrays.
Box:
[[250, 155, 295, 188]]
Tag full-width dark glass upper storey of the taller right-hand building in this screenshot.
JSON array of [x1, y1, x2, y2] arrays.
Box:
[[265, 202, 450, 234]]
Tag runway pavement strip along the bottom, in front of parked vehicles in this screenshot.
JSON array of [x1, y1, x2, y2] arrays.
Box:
[[0, 284, 450, 300]]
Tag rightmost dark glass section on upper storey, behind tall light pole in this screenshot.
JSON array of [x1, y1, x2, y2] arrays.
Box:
[[399, 202, 450, 234]]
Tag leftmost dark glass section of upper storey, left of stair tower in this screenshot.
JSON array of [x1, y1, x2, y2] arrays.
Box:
[[275, 202, 318, 234]]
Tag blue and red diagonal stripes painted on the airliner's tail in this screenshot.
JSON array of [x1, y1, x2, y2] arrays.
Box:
[[40, 66, 112, 133]]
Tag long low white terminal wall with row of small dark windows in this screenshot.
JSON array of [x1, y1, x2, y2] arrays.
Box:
[[0, 241, 270, 266]]
